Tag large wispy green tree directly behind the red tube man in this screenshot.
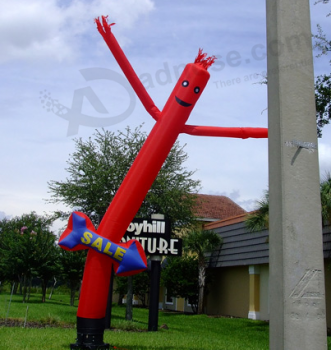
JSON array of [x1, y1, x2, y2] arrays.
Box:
[[48, 126, 200, 230]]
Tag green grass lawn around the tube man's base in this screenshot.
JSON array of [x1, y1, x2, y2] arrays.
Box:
[[0, 293, 331, 350]]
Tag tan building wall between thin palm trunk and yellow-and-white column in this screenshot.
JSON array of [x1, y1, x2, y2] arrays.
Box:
[[205, 266, 249, 318]]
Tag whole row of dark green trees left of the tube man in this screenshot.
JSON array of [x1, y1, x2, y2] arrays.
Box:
[[0, 212, 86, 305]]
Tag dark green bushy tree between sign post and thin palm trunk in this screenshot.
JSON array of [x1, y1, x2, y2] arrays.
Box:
[[161, 255, 199, 313]]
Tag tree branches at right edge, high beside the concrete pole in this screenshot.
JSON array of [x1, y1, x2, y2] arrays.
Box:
[[313, 0, 331, 137]]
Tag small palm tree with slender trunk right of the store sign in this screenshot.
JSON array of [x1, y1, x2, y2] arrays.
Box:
[[183, 230, 222, 314]]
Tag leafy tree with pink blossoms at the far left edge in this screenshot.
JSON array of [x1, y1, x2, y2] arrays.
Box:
[[0, 212, 57, 301]]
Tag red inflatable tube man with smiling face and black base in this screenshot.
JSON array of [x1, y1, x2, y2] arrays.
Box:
[[61, 16, 268, 348]]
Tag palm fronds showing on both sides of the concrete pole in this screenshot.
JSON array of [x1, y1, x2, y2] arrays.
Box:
[[245, 173, 331, 231]]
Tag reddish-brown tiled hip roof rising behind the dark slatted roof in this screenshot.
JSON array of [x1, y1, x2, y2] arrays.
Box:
[[194, 194, 246, 221]]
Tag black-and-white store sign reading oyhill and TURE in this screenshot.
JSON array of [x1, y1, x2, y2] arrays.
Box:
[[122, 219, 182, 256]]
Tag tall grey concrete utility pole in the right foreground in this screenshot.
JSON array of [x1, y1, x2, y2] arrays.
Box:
[[266, 0, 327, 350]]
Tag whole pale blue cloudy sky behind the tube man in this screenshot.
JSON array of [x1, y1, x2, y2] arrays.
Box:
[[0, 0, 331, 232]]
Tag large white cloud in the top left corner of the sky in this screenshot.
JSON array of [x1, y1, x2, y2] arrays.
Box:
[[0, 0, 154, 63]]
